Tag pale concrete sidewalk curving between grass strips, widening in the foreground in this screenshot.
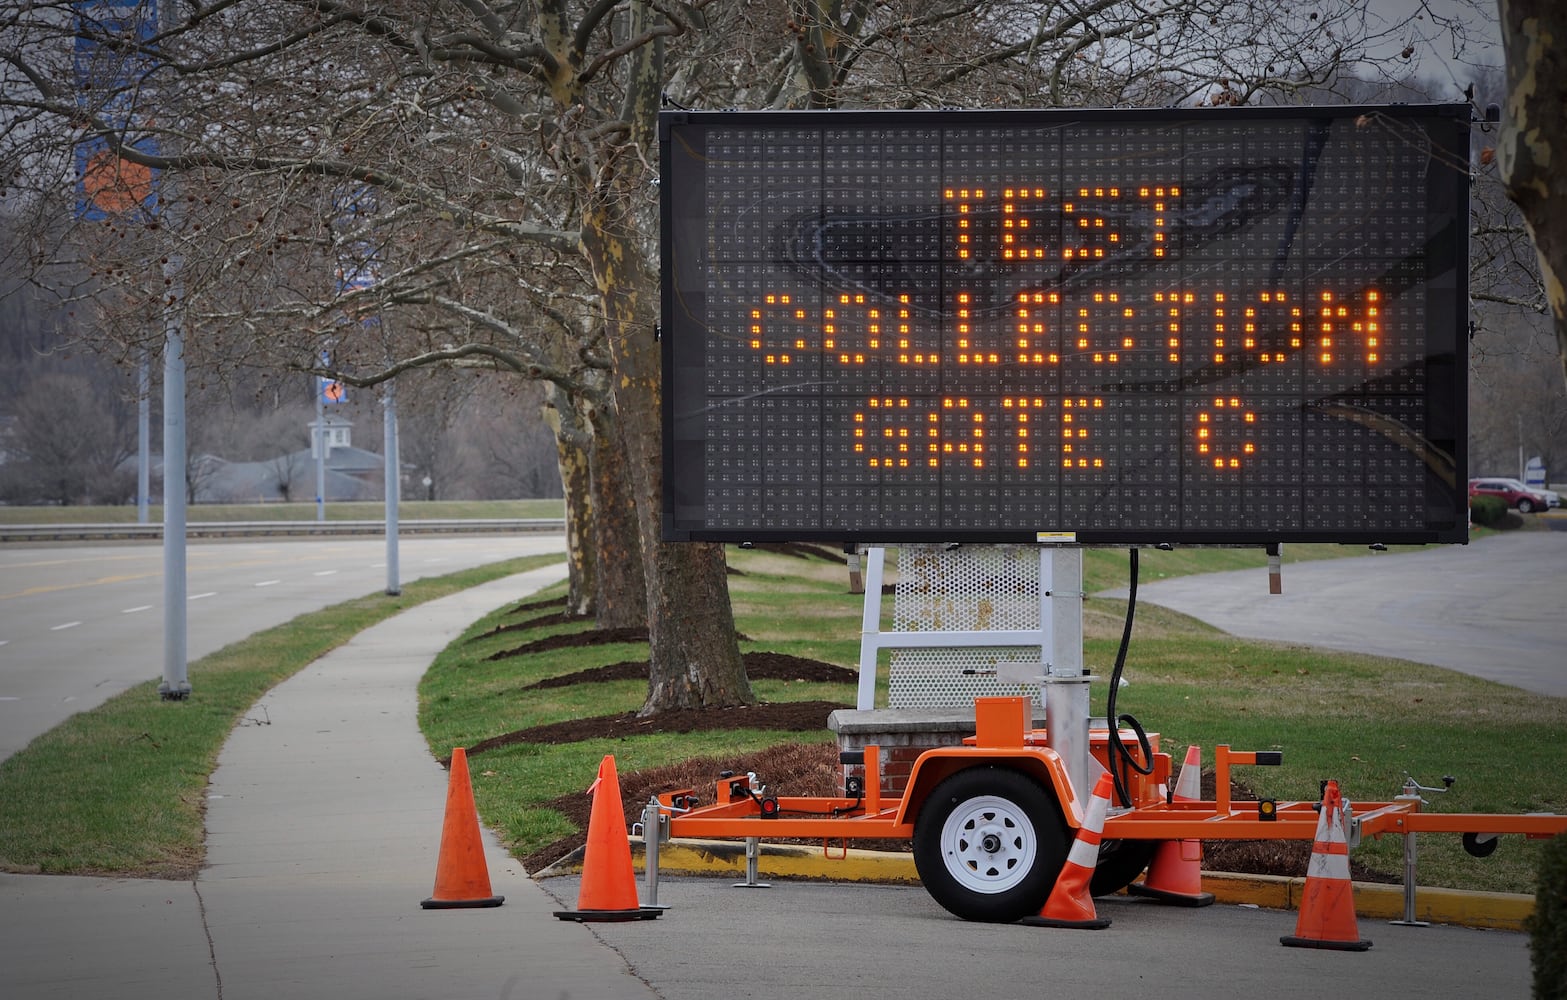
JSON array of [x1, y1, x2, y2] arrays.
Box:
[[0, 567, 657, 1000]]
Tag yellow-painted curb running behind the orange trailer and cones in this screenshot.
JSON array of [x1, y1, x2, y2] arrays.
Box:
[[533, 837, 1534, 931]]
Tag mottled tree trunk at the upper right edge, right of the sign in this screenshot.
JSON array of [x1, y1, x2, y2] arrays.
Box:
[[1498, 0, 1567, 394]]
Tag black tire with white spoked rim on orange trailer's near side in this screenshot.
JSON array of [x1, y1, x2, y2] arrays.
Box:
[[914, 766, 1067, 922]]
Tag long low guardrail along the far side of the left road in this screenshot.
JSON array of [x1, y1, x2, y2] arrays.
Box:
[[0, 517, 566, 542]]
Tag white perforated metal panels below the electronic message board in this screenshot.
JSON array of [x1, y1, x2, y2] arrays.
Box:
[[887, 545, 1047, 708]]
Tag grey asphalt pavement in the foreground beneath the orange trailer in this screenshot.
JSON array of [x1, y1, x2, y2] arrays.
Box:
[[542, 878, 1529, 1000]]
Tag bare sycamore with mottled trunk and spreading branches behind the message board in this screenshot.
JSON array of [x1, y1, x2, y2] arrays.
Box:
[[0, 0, 1466, 713]]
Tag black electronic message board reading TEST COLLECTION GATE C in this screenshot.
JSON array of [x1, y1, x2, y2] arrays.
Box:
[[660, 105, 1468, 544]]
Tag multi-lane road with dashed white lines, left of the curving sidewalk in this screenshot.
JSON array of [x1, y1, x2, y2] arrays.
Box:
[[0, 533, 566, 760]]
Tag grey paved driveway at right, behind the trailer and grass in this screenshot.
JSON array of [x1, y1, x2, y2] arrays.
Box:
[[1119, 531, 1567, 697]]
